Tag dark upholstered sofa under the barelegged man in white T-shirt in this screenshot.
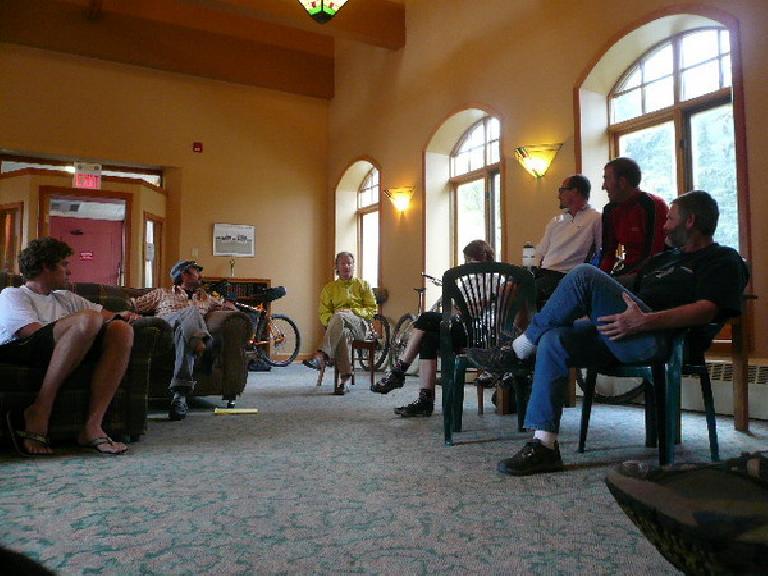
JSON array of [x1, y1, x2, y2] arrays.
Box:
[[0, 272, 172, 441]]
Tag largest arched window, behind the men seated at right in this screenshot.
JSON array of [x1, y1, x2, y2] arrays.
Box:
[[608, 27, 739, 249]]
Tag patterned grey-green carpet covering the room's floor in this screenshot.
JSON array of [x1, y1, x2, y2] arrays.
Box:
[[0, 365, 768, 576]]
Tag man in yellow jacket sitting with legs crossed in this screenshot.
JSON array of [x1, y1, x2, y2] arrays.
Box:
[[304, 252, 376, 390]]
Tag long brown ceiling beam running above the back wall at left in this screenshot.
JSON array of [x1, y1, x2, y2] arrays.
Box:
[[0, 0, 334, 98]]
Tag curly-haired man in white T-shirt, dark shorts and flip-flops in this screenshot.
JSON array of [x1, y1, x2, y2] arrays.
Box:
[[0, 238, 138, 456]]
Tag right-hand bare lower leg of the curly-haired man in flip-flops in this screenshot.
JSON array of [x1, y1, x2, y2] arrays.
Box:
[[78, 322, 133, 452]]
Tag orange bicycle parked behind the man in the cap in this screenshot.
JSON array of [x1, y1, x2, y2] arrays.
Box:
[[211, 281, 301, 369]]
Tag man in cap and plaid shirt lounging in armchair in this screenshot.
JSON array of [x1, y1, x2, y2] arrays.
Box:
[[133, 260, 235, 420]]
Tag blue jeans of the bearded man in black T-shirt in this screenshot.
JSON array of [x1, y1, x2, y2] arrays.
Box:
[[525, 264, 668, 432]]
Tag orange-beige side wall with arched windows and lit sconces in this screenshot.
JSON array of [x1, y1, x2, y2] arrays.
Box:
[[328, 0, 768, 358]]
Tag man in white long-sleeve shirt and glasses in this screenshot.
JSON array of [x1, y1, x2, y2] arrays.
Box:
[[534, 174, 602, 302]]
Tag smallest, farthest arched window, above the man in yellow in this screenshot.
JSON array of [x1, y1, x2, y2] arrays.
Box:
[[356, 166, 379, 288]]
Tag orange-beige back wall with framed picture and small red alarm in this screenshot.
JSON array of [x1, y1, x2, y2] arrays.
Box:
[[0, 44, 329, 351]]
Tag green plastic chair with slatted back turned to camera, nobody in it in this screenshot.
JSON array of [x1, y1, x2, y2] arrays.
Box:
[[440, 262, 536, 446]]
